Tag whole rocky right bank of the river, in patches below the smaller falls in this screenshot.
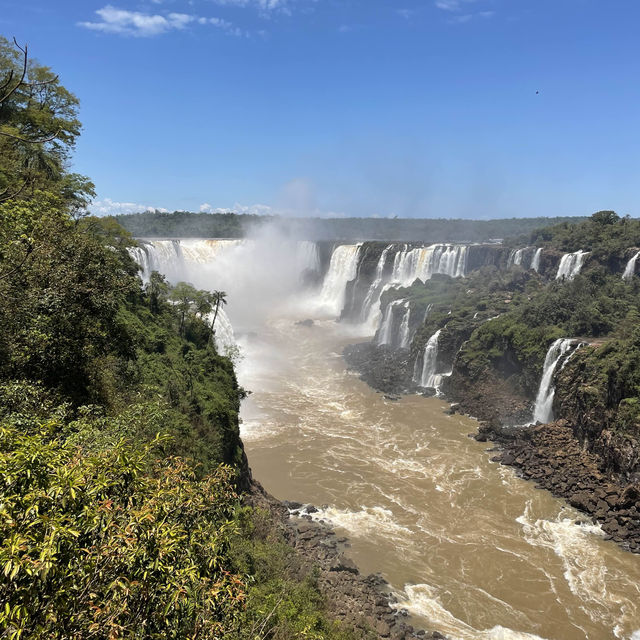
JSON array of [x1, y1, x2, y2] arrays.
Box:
[[344, 343, 640, 553]]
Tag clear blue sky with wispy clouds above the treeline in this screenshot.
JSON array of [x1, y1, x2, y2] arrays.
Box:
[[0, 0, 640, 218]]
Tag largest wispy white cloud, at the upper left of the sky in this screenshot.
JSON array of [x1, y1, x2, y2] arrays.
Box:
[[78, 5, 248, 38]]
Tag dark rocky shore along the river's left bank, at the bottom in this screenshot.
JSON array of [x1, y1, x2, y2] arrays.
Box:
[[246, 482, 446, 640]]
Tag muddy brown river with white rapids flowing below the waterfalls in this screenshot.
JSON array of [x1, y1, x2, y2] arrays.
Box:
[[239, 318, 640, 640]]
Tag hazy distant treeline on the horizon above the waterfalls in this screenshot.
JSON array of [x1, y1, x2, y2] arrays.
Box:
[[115, 211, 586, 242]]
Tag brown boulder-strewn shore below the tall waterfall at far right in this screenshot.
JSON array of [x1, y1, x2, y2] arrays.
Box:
[[477, 420, 640, 553]]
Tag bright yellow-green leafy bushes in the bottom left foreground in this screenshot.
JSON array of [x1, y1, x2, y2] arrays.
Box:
[[0, 420, 245, 639]]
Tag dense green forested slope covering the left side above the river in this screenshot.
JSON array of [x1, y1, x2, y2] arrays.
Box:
[[0, 39, 360, 640]]
